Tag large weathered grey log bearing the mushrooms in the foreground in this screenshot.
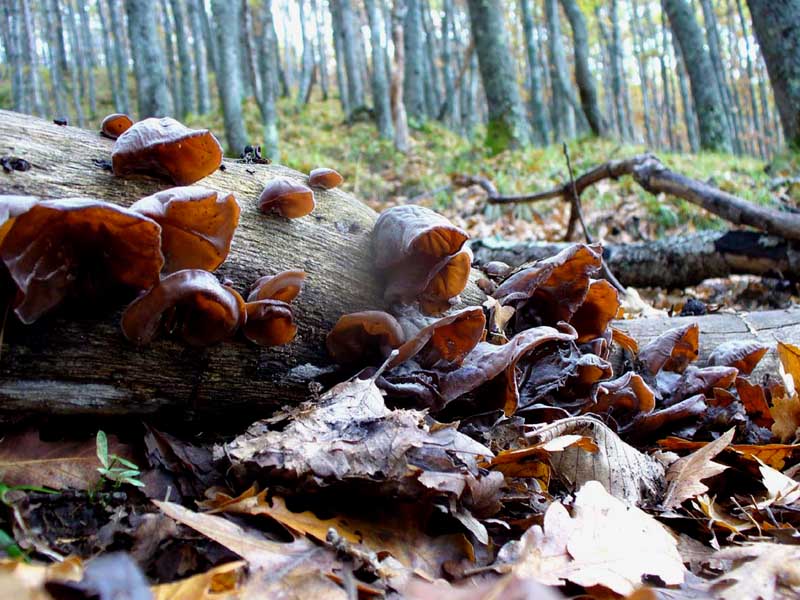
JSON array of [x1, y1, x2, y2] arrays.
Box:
[[0, 111, 800, 427]]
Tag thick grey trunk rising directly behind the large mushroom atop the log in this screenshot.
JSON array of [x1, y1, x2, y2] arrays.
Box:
[[125, 0, 170, 119]]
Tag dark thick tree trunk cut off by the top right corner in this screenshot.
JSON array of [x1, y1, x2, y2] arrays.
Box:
[[747, 0, 800, 150]]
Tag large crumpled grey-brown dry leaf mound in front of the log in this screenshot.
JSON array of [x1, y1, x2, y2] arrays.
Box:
[[215, 372, 492, 499]]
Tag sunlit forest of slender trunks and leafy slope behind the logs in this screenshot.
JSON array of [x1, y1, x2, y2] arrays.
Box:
[[0, 0, 800, 260]]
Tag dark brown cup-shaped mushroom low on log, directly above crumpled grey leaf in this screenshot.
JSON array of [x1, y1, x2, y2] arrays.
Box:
[[325, 310, 405, 365]]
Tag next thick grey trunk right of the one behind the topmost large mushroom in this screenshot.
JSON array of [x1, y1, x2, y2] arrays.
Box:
[[211, 0, 248, 156]]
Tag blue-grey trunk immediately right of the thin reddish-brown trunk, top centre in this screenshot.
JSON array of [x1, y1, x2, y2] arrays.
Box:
[[395, 0, 427, 123]]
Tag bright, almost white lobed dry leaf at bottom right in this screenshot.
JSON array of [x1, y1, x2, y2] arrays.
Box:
[[495, 481, 686, 595]]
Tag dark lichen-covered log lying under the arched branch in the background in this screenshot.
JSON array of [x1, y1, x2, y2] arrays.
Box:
[[470, 231, 800, 288]]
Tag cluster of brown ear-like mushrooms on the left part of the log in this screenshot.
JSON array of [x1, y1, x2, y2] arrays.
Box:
[[0, 114, 313, 346]]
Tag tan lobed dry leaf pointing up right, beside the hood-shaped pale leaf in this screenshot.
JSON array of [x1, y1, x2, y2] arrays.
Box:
[[661, 429, 735, 510]]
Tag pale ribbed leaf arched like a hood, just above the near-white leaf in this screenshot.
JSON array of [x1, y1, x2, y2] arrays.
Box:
[[531, 417, 664, 506]]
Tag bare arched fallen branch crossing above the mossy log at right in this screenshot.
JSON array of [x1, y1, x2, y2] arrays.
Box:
[[462, 154, 800, 240]]
